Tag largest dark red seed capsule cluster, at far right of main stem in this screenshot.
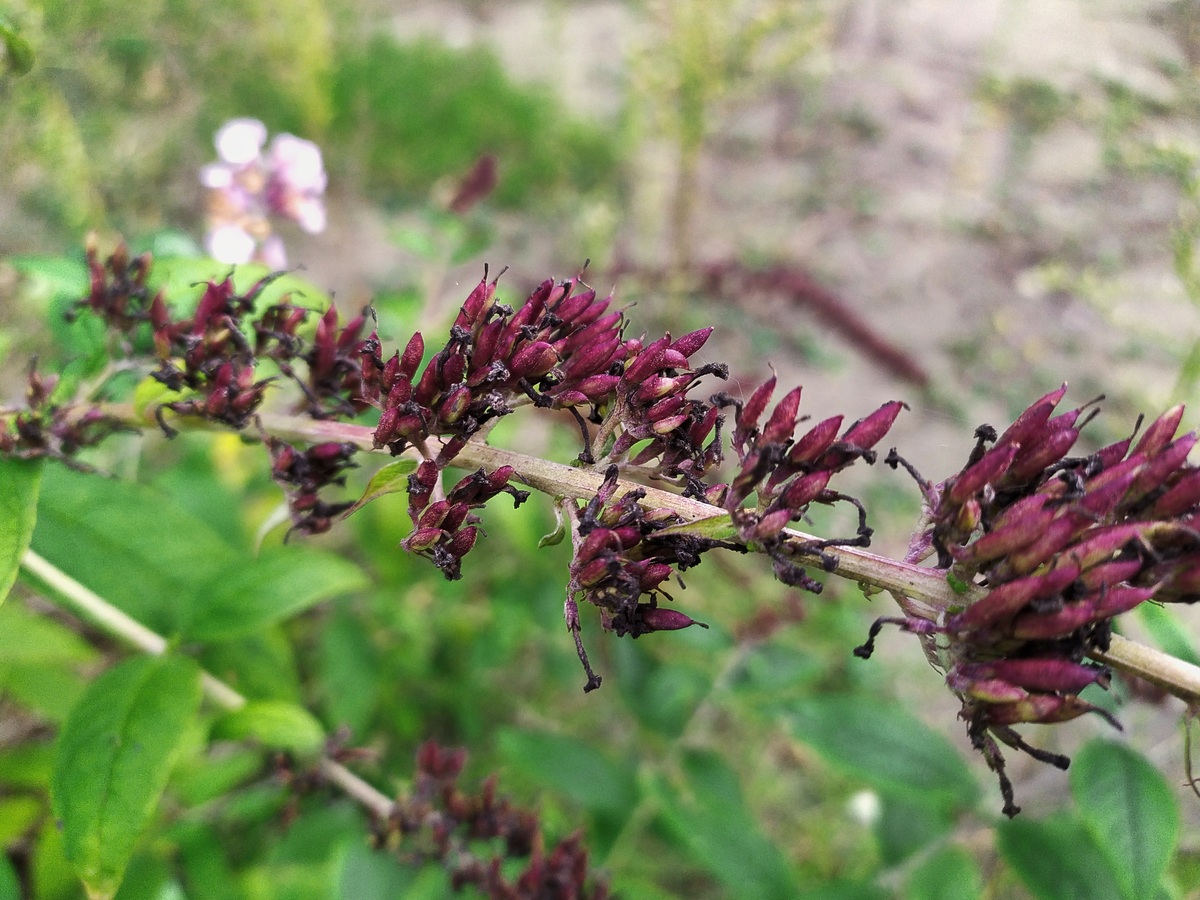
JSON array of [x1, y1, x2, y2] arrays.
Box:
[[856, 385, 1200, 816]]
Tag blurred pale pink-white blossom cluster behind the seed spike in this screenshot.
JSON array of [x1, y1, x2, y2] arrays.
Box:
[[200, 119, 328, 269]]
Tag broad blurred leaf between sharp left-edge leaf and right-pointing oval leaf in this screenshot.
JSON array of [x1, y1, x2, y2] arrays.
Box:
[[34, 467, 246, 634]]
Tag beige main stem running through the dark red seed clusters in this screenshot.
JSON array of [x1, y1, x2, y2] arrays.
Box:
[[102, 404, 1200, 704]]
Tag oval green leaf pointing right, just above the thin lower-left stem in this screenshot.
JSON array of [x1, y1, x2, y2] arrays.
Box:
[[182, 547, 367, 641]]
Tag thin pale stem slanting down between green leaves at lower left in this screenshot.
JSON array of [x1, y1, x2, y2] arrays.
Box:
[[20, 550, 395, 818]]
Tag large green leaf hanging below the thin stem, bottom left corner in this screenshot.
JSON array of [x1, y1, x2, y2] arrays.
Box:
[[50, 656, 200, 898]]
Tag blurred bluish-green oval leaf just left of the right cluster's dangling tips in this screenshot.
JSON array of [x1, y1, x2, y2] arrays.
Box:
[[786, 695, 978, 806]]
